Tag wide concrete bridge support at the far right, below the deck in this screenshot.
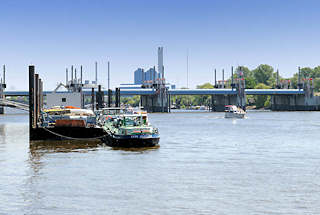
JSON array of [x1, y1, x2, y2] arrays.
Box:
[[271, 95, 320, 111]]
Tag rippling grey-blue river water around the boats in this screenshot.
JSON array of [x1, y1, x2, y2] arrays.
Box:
[[0, 109, 320, 215]]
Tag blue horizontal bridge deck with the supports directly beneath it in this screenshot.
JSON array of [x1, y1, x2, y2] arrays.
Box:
[[0, 88, 320, 112]]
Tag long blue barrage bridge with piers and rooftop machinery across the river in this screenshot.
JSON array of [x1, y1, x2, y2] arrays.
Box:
[[0, 63, 320, 112]]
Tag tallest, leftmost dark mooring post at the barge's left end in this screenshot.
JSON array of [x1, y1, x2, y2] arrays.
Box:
[[29, 65, 35, 140]]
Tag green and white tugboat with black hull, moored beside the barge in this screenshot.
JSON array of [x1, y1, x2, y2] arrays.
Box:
[[102, 108, 160, 148]]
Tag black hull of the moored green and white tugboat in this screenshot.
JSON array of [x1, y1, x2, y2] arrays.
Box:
[[103, 134, 160, 148]]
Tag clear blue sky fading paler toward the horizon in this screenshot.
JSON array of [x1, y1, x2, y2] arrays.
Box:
[[0, 0, 320, 90]]
